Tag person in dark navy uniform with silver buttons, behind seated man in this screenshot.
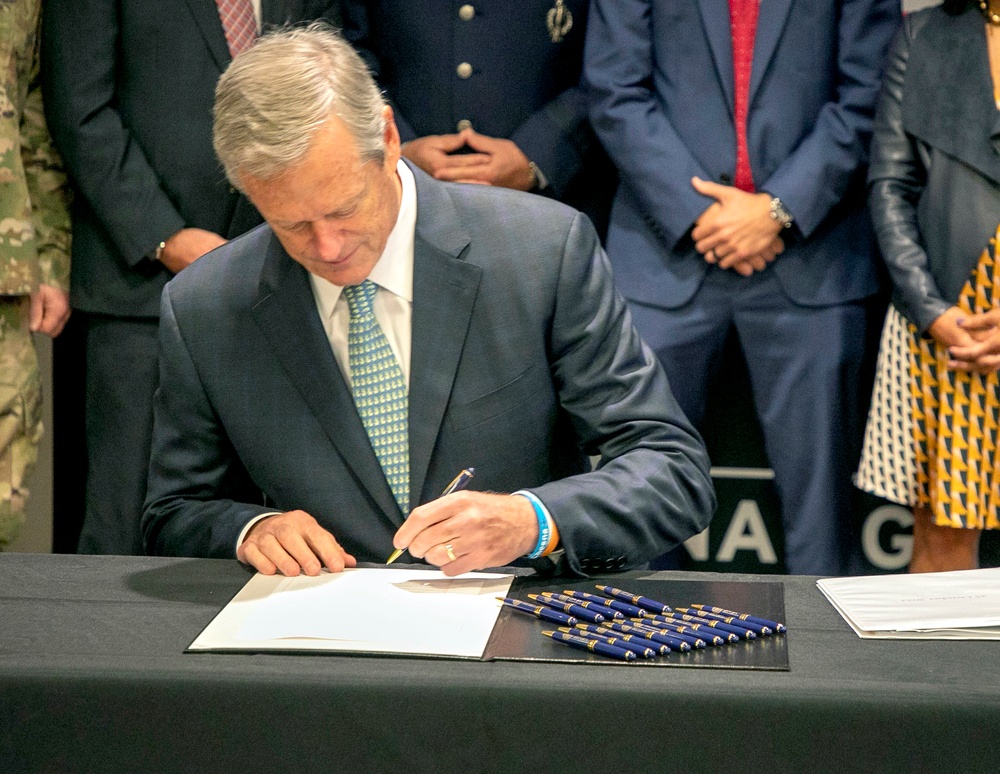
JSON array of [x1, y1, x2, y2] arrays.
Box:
[[343, 0, 615, 234]]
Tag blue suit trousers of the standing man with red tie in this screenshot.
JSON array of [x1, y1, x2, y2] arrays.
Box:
[[631, 266, 877, 575]]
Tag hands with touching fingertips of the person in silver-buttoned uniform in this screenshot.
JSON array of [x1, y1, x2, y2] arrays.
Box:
[[403, 129, 534, 191]]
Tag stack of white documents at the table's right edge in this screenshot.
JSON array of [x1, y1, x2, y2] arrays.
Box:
[[816, 568, 1000, 640]]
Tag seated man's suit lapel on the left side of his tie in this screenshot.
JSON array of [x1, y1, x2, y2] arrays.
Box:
[[252, 236, 403, 526]]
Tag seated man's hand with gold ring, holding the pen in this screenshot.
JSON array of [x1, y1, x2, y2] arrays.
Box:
[[392, 492, 538, 575]]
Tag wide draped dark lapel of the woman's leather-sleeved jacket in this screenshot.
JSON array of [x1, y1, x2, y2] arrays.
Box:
[[903, 11, 1000, 183]]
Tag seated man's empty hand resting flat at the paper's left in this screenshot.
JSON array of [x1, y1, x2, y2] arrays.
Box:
[[236, 511, 358, 576]]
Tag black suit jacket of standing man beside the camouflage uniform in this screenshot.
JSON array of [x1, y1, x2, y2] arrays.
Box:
[[42, 0, 336, 317]]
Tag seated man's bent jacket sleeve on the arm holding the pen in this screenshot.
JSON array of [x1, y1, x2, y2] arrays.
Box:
[[532, 214, 716, 574]]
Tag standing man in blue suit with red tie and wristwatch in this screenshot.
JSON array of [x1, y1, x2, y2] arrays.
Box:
[[585, 0, 900, 574]]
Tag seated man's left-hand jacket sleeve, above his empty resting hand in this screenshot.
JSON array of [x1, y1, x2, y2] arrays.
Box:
[[141, 285, 274, 559]]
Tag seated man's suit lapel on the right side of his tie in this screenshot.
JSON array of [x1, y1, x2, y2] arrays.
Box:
[[409, 170, 482, 503]]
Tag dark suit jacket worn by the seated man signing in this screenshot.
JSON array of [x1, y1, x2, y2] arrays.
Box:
[[143, 165, 714, 573]]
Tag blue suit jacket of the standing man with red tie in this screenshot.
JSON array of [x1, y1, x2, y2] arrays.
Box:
[[585, 0, 900, 308]]
